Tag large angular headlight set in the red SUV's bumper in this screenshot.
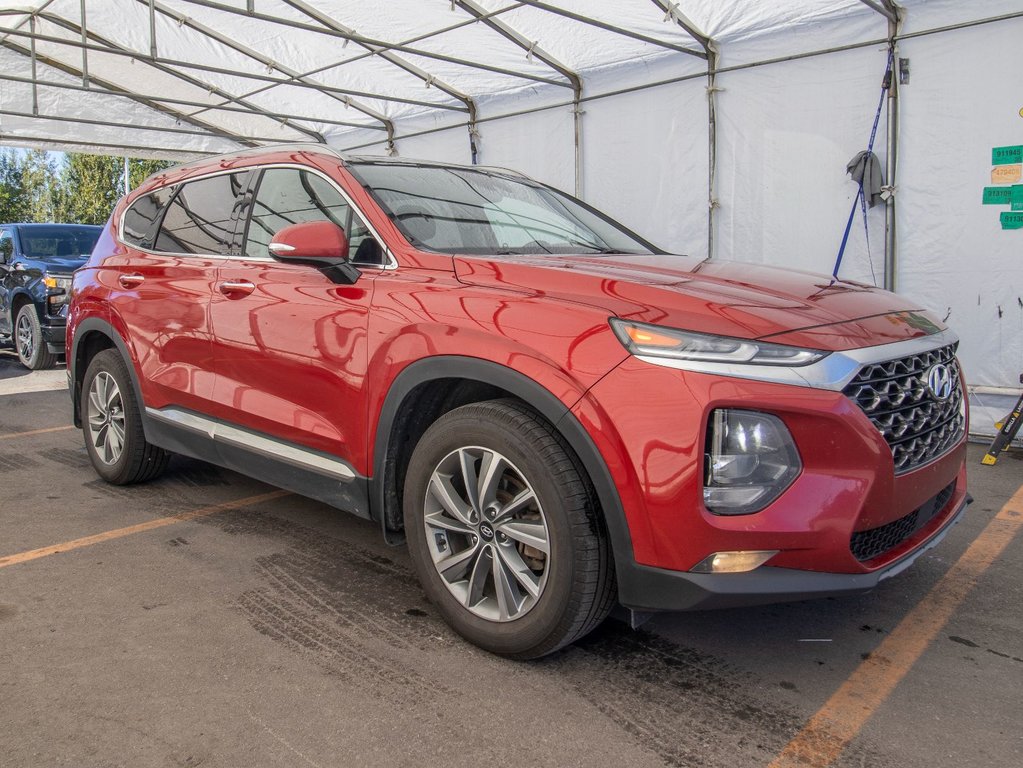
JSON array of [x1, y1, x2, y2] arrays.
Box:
[[704, 408, 803, 514]]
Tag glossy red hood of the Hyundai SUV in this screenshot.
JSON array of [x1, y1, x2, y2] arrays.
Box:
[[454, 255, 943, 351]]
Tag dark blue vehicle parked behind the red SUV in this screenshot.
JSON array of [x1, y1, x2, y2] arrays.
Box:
[[0, 224, 102, 370]]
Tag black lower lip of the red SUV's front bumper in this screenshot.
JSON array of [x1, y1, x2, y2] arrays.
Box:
[[618, 494, 973, 613]]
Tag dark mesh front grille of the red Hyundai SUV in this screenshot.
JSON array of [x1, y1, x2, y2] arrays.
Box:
[[842, 344, 966, 475]]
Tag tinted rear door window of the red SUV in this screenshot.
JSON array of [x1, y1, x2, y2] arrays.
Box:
[[155, 173, 247, 254]]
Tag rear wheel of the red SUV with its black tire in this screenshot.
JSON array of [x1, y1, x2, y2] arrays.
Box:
[[80, 350, 170, 486]]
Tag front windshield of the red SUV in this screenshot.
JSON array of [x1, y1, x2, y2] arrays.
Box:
[[350, 163, 656, 256]]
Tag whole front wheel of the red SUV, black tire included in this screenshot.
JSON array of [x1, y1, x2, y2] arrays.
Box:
[[404, 400, 616, 659]]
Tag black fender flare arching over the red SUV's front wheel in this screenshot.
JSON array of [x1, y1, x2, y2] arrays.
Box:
[[370, 355, 634, 574]]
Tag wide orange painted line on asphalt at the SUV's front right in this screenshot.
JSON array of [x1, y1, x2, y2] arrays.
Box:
[[769, 487, 1023, 768]]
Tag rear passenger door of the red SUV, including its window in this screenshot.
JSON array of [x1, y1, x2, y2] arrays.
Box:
[[107, 171, 250, 413]]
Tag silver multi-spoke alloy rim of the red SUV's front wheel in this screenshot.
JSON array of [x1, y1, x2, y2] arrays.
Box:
[[424, 447, 550, 622]]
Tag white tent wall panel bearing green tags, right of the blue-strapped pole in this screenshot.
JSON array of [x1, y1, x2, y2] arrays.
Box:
[[897, 14, 1023, 387]]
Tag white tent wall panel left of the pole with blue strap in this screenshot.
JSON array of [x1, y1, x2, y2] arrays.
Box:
[[715, 48, 888, 284]]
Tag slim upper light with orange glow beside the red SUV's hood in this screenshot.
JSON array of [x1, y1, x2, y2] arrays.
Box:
[[611, 317, 828, 366]]
